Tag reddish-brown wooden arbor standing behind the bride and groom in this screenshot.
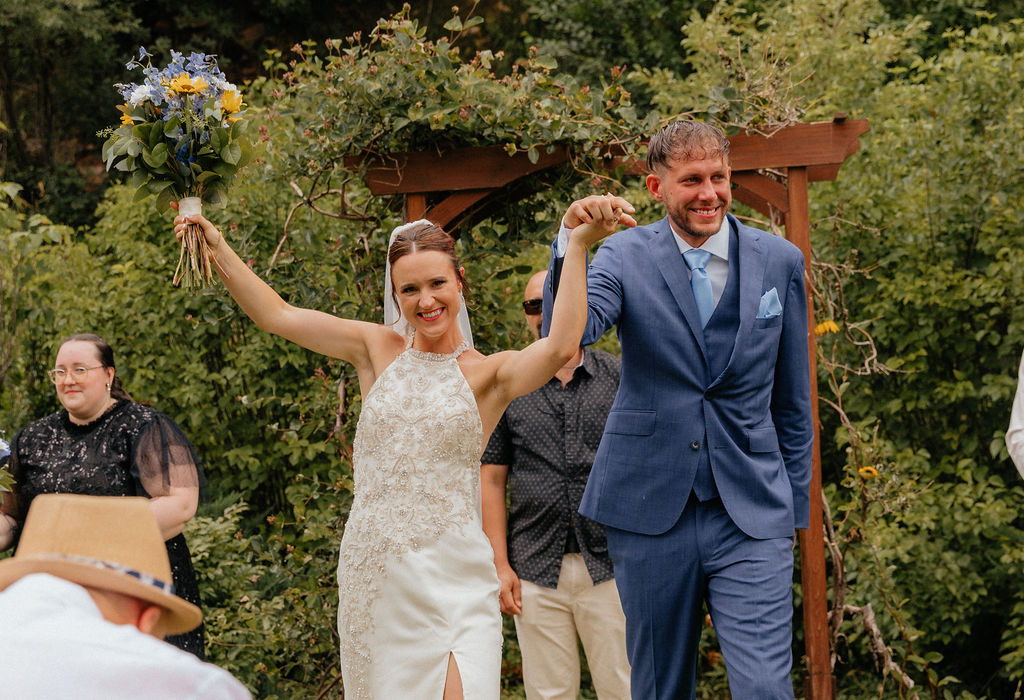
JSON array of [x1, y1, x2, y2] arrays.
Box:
[[353, 115, 868, 700]]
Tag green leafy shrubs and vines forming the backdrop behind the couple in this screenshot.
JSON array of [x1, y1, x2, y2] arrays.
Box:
[[9, 0, 1024, 699]]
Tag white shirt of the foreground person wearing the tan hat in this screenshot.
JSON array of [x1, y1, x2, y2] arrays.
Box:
[[0, 573, 252, 700]]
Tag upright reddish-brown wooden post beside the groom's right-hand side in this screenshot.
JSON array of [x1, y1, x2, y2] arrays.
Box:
[[785, 168, 834, 700]]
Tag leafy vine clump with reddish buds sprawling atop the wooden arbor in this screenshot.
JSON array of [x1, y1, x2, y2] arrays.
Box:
[[268, 8, 651, 177]]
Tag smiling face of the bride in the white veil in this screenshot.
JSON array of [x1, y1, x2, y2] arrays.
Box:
[[391, 251, 462, 337]]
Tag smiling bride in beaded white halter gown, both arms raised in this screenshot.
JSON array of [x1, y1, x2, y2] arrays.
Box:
[[174, 195, 636, 700]]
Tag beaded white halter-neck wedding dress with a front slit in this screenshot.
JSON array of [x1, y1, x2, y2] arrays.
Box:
[[338, 340, 502, 700]]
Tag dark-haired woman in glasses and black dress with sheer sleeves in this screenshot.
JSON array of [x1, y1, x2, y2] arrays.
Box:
[[0, 334, 204, 658]]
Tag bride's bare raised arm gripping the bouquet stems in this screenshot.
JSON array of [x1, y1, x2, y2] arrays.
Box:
[[174, 208, 401, 376]]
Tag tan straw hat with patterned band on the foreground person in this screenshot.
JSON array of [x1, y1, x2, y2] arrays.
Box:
[[0, 493, 203, 635]]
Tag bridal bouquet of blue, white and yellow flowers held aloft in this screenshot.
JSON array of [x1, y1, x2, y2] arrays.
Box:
[[100, 48, 252, 290]]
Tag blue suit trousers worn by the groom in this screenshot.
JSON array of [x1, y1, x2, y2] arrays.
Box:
[[607, 494, 794, 700]]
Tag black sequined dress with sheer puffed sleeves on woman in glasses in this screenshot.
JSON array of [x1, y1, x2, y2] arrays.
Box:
[[8, 399, 205, 658]]
